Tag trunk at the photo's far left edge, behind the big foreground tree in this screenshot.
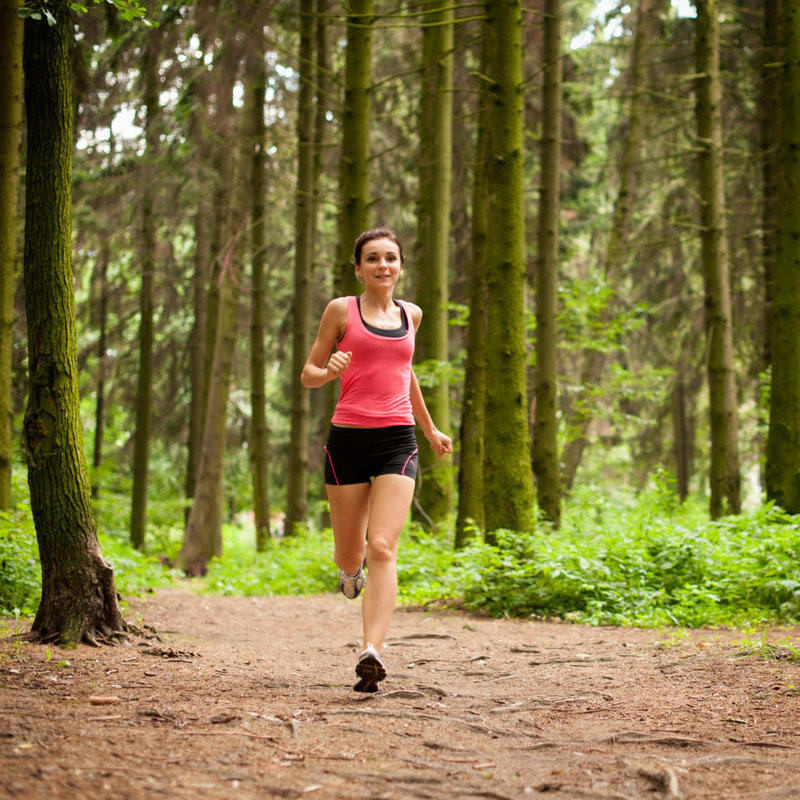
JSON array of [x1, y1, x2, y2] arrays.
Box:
[[0, 0, 22, 511]]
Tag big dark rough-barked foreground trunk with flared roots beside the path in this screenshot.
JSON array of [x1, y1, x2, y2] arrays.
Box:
[[23, 0, 124, 644]]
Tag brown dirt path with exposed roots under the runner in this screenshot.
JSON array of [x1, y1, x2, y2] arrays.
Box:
[[0, 589, 800, 800]]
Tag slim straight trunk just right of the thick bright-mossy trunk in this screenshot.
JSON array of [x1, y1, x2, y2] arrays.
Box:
[[533, 0, 562, 527]]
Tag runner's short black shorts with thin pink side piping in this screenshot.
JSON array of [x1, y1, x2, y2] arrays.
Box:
[[325, 425, 417, 486]]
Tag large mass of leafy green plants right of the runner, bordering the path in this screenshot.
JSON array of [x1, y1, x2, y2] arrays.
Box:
[[404, 490, 800, 627]]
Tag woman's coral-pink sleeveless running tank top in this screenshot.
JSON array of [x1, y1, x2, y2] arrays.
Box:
[[331, 297, 415, 428]]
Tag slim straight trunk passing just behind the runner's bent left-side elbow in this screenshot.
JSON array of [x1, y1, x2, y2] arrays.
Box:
[[285, 0, 315, 534]]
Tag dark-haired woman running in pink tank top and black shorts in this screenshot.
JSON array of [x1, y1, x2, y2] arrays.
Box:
[[300, 228, 452, 692]]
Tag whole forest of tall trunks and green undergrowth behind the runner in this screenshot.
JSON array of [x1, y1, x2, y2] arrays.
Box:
[[0, 0, 800, 640]]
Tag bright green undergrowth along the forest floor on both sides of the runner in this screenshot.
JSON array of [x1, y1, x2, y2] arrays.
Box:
[[0, 488, 800, 630]]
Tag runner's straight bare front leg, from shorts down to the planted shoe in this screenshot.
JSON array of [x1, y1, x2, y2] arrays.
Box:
[[361, 475, 414, 652]]
